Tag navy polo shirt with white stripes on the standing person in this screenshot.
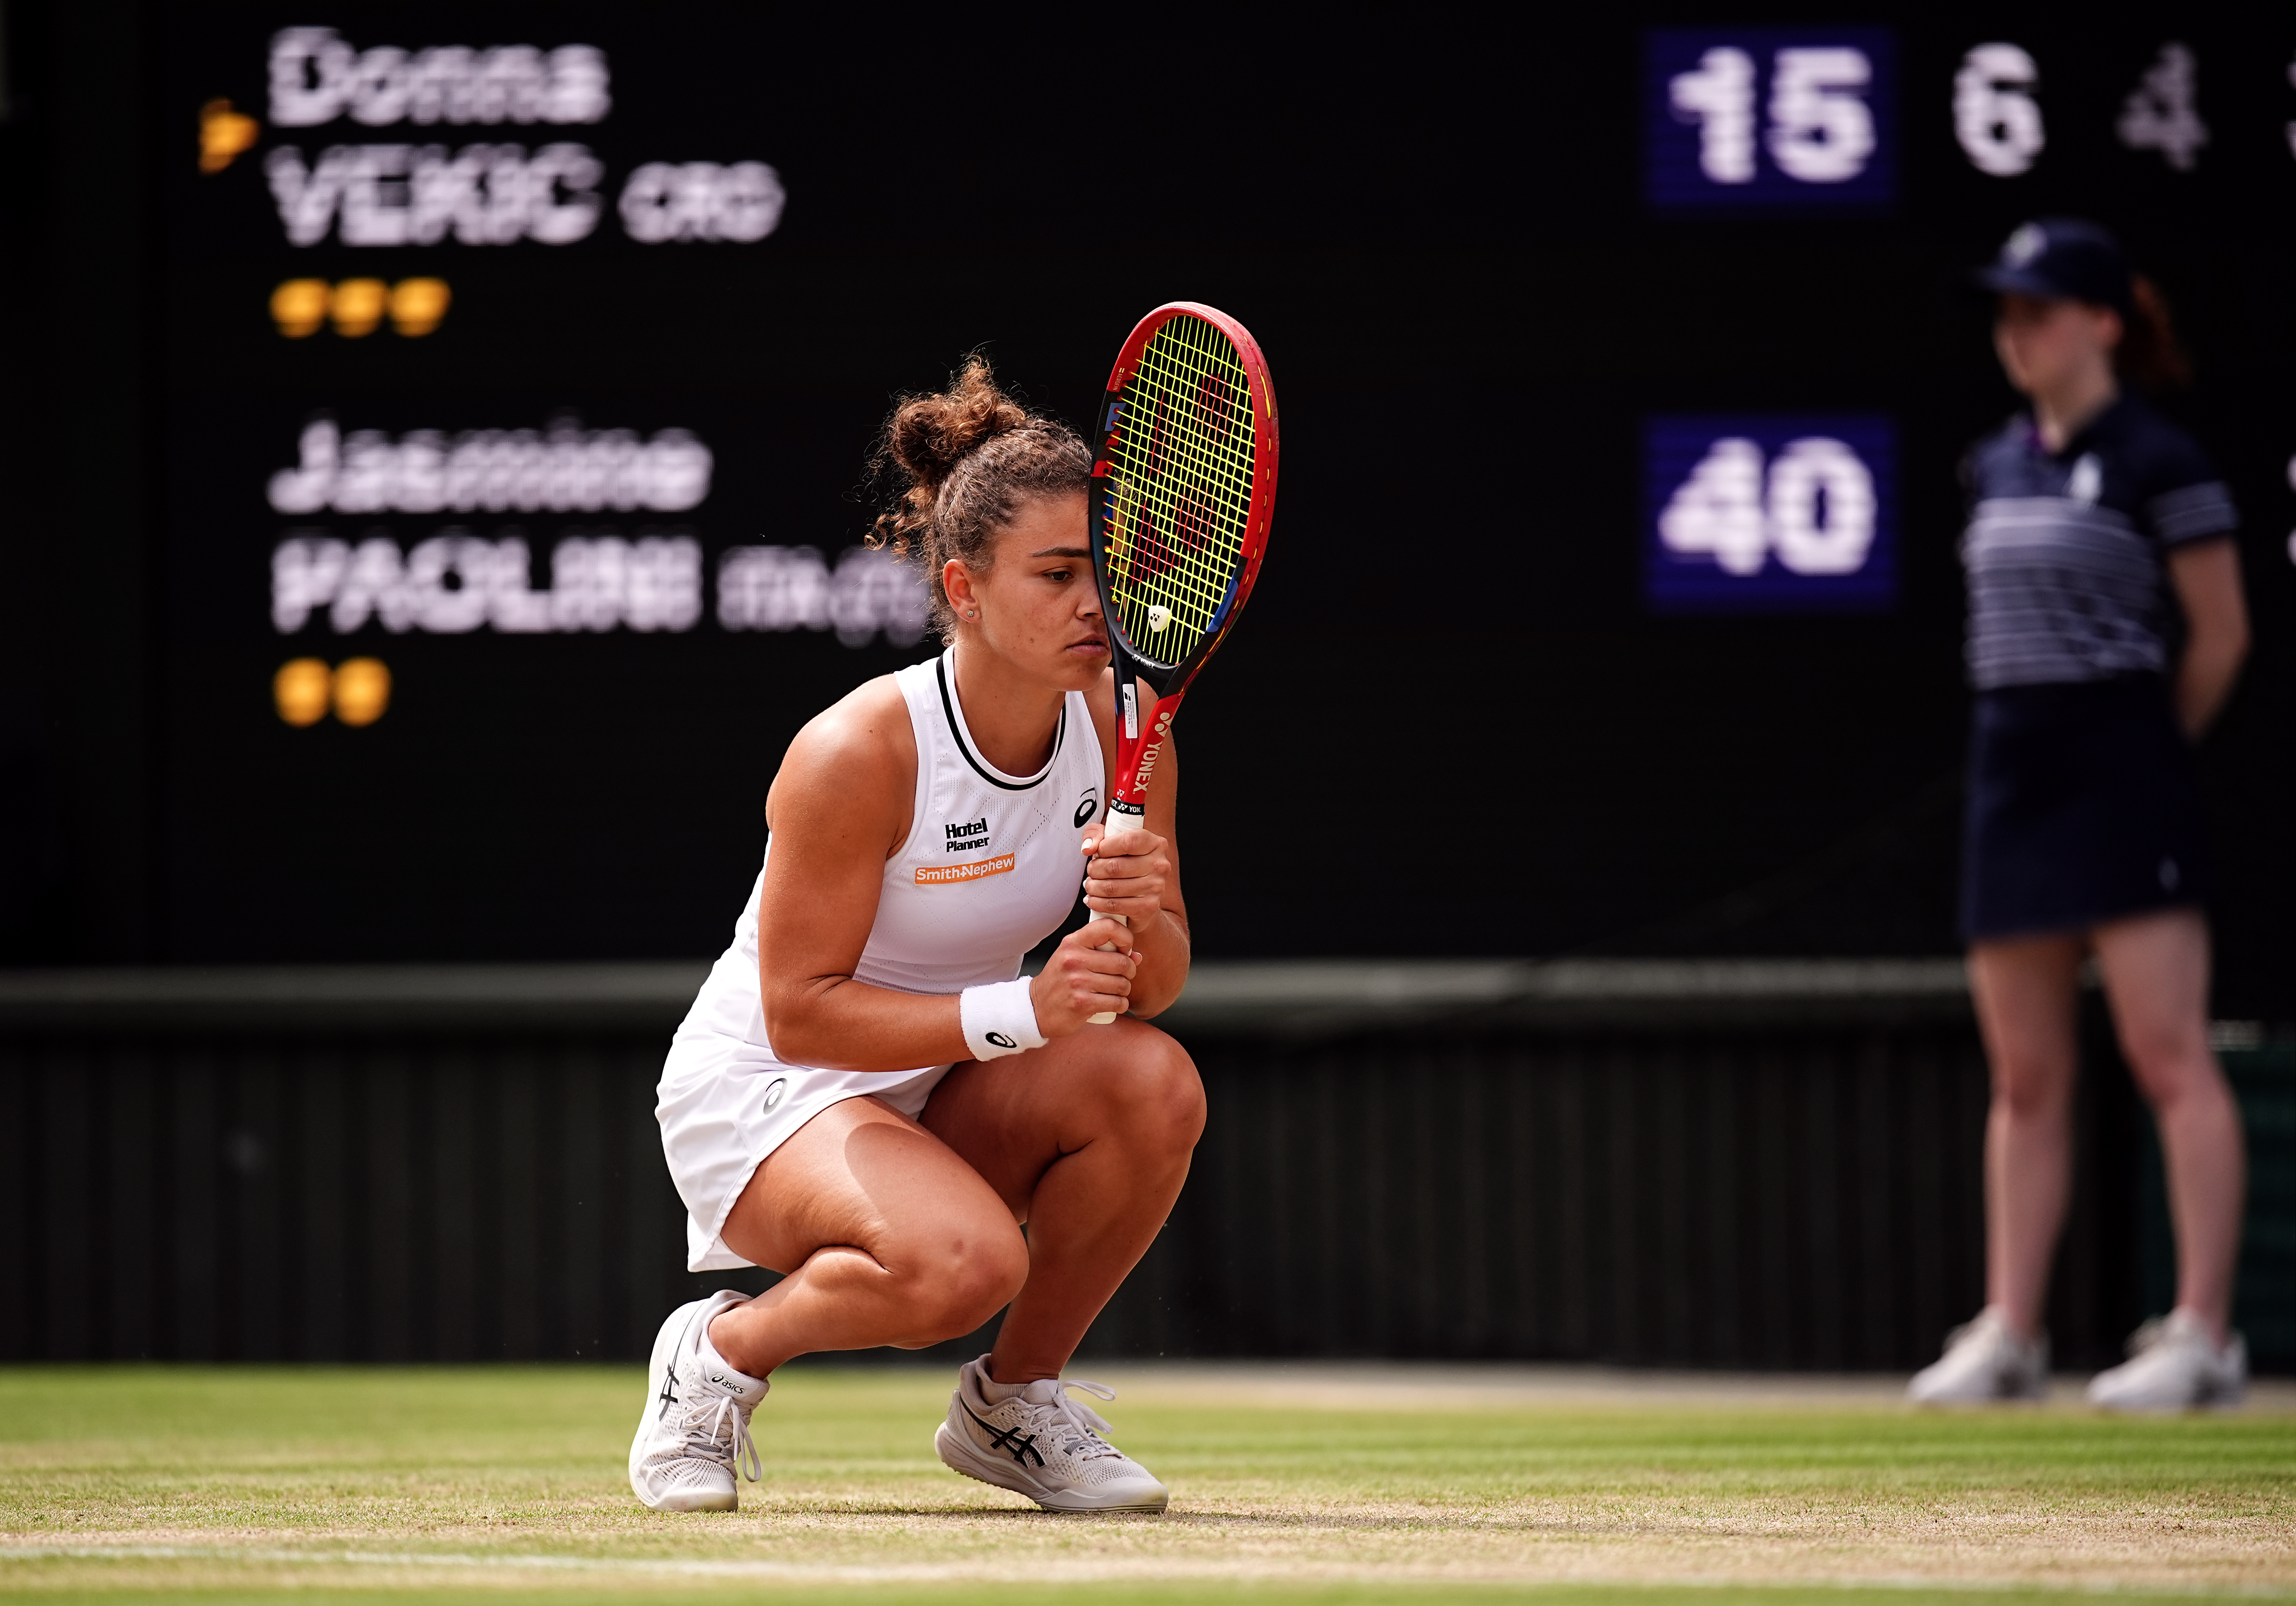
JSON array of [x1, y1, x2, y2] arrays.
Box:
[[1961, 395, 2239, 689]]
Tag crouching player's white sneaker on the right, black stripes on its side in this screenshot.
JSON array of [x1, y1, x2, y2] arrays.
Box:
[[932, 1356, 1171, 1512]]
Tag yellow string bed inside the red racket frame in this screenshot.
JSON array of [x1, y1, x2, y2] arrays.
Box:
[[1109, 315, 1256, 664]]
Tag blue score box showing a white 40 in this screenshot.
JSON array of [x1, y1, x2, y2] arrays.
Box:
[[1642, 414, 1896, 613]]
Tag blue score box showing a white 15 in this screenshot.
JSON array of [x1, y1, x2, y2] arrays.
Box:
[[1642, 27, 1899, 214]]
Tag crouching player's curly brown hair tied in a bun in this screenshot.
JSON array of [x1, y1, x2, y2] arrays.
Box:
[[868, 356, 1093, 641]]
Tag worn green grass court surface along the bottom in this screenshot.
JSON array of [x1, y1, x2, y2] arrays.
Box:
[[0, 1365, 2296, 1606]]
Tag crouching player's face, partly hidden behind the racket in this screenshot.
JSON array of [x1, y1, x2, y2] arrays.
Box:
[[950, 491, 1109, 692]]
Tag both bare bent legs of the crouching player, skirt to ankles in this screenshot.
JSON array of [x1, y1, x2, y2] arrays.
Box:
[[709, 1020, 1203, 1383]]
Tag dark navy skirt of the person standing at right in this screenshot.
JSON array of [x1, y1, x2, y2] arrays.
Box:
[[1961, 675, 2209, 940]]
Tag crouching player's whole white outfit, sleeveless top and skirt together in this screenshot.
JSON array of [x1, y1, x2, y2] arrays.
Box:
[[654, 650, 1104, 1270]]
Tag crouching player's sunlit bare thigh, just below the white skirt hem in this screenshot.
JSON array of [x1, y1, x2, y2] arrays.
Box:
[[721, 1098, 1015, 1273]]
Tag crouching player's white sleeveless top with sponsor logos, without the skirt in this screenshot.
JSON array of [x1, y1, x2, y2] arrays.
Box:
[[680, 648, 1104, 1075]]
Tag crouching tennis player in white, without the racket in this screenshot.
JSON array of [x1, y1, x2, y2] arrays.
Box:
[[629, 358, 1203, 1512]]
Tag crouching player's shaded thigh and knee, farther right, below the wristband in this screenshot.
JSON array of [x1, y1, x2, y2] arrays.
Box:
[[923, 1015, 1203, 1220]]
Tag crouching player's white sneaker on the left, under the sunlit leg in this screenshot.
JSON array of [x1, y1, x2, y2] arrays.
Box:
[[629, 1289, 767, 1512]]
